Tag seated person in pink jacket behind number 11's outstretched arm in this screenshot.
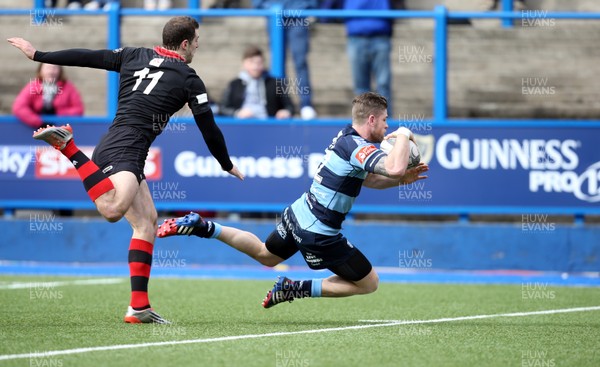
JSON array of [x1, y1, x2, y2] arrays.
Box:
[[13, 63, 83, 129]]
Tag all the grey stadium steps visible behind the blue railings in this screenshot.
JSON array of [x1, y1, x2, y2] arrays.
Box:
[[0, 0, 600, 118]]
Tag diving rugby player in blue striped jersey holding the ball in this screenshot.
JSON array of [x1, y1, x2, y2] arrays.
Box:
[[157, 92, 429, 308]]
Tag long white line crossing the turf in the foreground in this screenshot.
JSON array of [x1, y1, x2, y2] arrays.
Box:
[[0, 306, 600, 361]]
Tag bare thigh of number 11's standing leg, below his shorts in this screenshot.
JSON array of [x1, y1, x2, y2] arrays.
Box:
[[125, 180, 158, 237]]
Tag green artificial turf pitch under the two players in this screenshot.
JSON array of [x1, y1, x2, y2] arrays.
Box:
[[0, 276, 600, 367]]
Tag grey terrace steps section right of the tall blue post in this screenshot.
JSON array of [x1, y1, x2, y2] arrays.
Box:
[[449, 21, 600, 118]]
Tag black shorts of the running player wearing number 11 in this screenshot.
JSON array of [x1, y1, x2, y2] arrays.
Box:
[[92, 125, 152, 183]]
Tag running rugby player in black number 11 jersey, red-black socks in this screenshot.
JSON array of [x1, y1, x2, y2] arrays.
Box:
[[8, 16, 244, 323]]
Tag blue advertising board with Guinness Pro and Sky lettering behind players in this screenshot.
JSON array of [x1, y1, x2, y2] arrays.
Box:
[[0, 123, 600, 211]]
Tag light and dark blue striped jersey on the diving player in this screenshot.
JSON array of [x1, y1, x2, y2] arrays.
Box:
[[291, 125, 385, 236]]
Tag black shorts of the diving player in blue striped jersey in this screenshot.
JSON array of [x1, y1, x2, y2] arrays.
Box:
[[266, 207, 373, 281]]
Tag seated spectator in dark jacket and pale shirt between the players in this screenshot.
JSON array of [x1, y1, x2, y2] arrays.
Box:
[[220, 46, 294, 119]]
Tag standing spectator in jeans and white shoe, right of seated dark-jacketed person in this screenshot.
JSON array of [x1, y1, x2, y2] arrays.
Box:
[[252, 0, 318, 120]]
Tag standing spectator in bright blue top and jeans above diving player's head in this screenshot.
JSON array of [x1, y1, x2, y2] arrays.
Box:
[[344, 0, 393, 116]]
